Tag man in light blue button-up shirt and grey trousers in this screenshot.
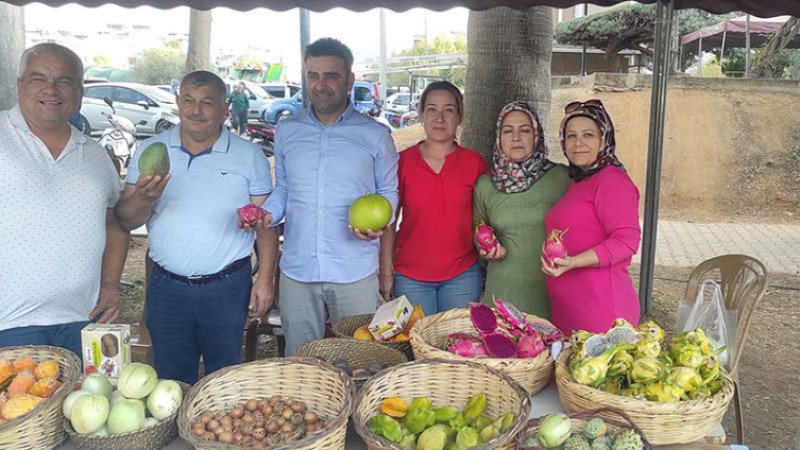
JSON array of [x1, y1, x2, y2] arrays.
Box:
[[264, 38, 398, 355]]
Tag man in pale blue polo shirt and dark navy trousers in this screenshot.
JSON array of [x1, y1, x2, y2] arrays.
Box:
[[116, 71, 277, 384]]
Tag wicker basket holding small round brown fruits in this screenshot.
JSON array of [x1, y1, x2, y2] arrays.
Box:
[[178, 357, 355, 450]]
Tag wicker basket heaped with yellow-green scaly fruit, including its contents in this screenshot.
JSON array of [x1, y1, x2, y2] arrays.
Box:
[[556, 319, 734, 445]]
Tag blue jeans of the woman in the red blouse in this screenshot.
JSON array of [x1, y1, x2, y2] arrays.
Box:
[[394, 262, 482, 316]]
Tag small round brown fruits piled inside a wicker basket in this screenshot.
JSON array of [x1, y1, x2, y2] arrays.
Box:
[[192, 395, 325, 448]]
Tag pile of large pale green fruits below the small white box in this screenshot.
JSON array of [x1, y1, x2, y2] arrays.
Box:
[[62, 363, 183, 436]]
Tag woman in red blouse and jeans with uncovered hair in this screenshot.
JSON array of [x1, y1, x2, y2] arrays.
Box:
[[380, 81, 488, 315]]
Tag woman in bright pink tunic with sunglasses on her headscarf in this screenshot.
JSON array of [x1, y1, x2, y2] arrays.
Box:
[[542, 100, 641, 334]]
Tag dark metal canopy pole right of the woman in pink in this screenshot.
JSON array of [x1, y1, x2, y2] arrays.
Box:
[[639, 0, 675, 313]]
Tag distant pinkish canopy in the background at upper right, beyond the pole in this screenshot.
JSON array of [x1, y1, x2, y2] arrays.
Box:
[[681, 16, 800, 48]]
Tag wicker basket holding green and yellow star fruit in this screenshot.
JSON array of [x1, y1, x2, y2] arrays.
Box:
[[353, 359, 531, 450]]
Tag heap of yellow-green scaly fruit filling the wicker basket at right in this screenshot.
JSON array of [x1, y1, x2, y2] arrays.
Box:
[[569, 319, 728, 402]]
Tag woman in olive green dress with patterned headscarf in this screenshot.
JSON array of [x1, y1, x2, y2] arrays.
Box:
[[473, 101, 570, 318]]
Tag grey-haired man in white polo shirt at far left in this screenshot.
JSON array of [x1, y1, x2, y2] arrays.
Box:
[[0, 43, 128, 355]]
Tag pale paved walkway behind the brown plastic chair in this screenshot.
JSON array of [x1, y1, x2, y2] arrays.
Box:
[[634, 220, 800, 274]]
